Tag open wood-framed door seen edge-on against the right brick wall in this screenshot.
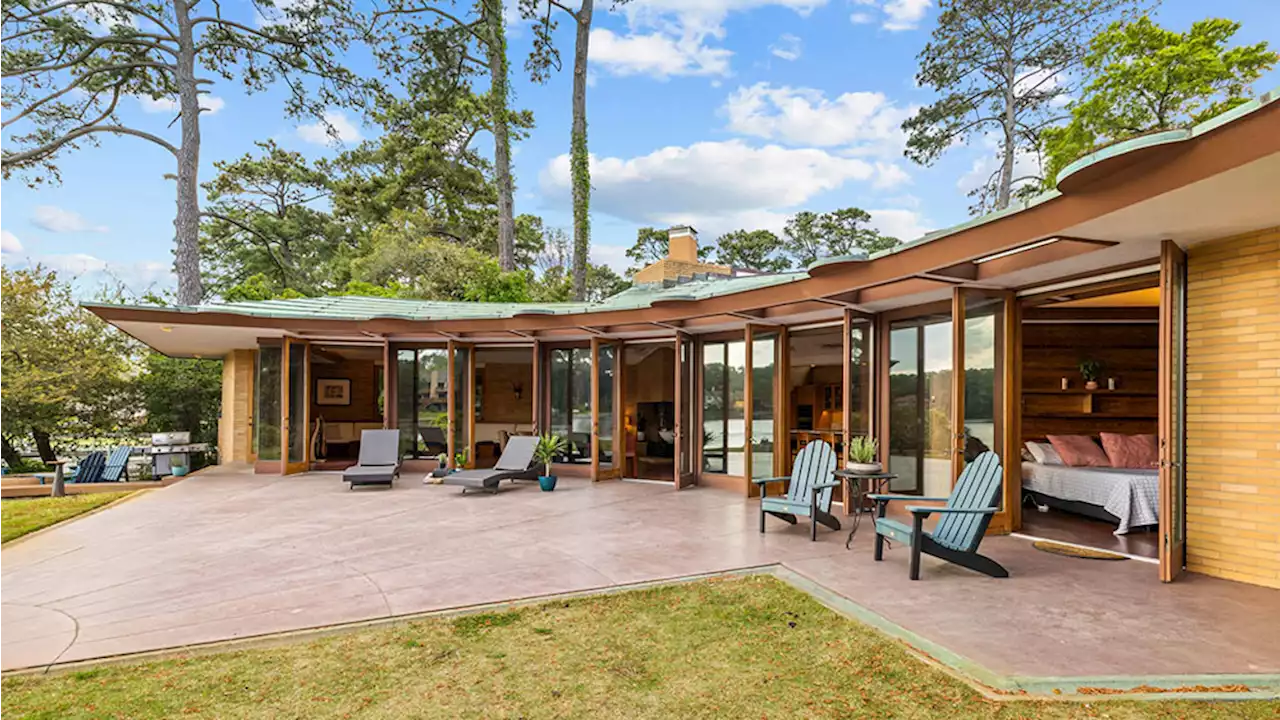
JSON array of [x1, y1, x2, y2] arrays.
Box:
[[1157, 240, 1187, 583]]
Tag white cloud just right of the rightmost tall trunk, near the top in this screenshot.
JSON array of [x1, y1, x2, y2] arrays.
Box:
[[591, 28, 733, 79]]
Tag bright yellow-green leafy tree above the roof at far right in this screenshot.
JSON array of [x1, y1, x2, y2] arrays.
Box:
[[1044, 15, 1280, 187]]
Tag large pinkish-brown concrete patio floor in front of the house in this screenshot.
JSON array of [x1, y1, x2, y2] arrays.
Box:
[[0, 470, 1280, 676]]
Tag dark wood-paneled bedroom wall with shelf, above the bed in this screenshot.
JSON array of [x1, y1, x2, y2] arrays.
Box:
[[1021, 322, 1160, 439]]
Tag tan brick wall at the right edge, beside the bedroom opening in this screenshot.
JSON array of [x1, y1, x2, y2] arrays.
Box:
[[1187, 228, 1280, 587]]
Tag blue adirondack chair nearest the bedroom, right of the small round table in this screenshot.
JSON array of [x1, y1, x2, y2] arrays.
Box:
[[868, 452, 1009, 580]]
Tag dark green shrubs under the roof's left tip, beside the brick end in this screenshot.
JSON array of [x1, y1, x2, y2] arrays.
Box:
[[134, 352, 223, 443]]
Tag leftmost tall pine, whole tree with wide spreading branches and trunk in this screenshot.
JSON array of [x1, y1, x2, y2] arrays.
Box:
[[0, 0, 364, 304]]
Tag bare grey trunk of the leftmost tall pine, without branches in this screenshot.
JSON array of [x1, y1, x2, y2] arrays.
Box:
[[173, 0, 205, 305]]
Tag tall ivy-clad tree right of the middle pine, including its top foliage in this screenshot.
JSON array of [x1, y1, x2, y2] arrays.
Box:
[[520, 0, 631, 300]]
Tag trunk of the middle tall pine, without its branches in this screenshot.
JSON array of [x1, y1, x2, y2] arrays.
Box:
[[484, 0, 516, 270]]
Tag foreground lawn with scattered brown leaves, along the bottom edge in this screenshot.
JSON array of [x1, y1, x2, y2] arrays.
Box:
[[0, 577, 1280, 720]]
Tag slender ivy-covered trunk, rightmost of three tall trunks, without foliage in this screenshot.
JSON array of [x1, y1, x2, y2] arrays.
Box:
[[570, 0, 595, 301]]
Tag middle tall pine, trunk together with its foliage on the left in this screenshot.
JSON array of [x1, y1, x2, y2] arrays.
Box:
[[370, 0, 516, 272]]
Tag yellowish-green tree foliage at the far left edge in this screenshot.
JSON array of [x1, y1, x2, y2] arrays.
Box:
[[0, 265, 129, 462]]
